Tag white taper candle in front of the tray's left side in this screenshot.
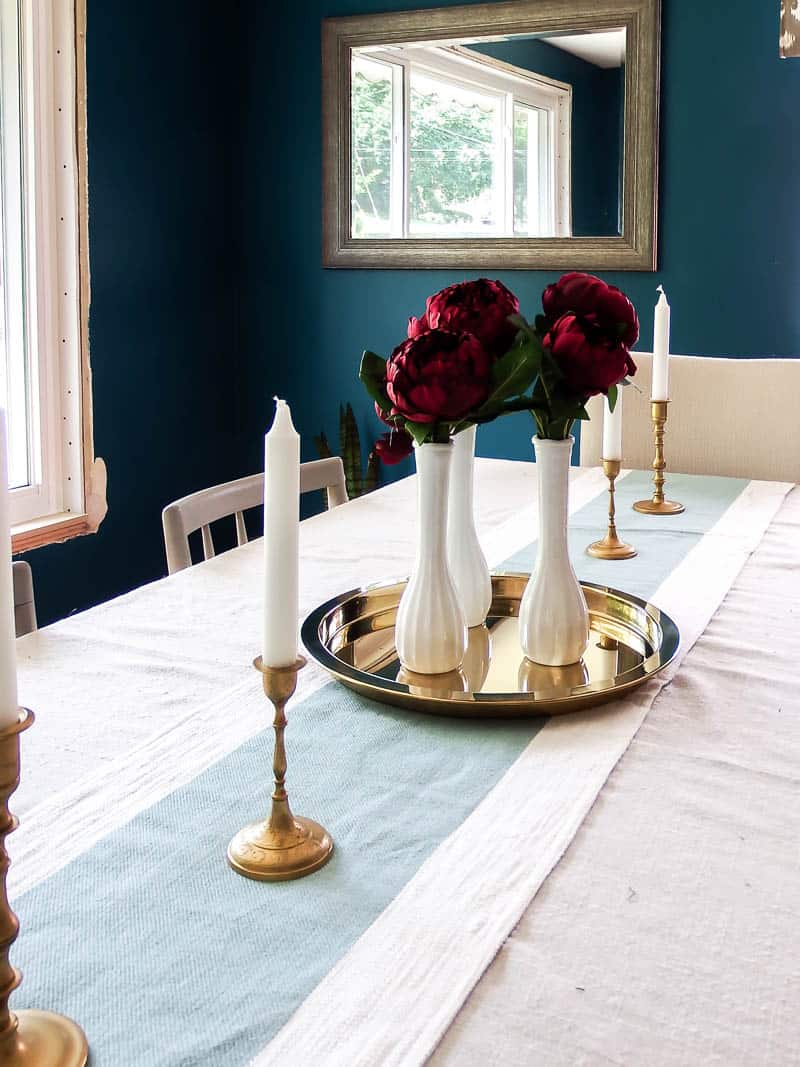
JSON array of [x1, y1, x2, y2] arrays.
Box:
[[261, 397, 300, 667]]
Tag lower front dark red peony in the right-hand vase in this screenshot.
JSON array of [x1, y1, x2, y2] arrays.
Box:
[[544, 315, 636, 397]]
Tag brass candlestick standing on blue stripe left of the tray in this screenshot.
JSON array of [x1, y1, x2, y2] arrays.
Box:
[[228, 656, 333, 881]]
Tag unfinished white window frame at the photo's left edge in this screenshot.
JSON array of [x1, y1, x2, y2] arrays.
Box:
[[0, 0, 100, 552]]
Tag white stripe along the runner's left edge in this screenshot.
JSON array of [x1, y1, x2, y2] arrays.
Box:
[[7, 468, 614, 898]]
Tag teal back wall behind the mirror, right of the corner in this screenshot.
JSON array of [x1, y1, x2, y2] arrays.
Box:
[[237, 0, 800, 484]]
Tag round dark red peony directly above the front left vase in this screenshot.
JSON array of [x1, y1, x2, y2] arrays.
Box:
[[386, 330, 492, 423]]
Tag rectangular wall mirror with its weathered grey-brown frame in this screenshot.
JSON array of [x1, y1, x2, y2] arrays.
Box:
[[323, 0, 658, 270]]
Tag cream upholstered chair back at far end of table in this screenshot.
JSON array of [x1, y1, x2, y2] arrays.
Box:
[[580, 352, 800, 482]]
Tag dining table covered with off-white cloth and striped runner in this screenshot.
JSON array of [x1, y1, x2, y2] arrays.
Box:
[[7, 459, 800, 1067]]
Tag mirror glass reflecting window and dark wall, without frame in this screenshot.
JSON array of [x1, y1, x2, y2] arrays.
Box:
[[350, 29, 626, 239]]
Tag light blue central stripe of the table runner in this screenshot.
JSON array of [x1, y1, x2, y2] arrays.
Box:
[[12, 474, 747, 1067]]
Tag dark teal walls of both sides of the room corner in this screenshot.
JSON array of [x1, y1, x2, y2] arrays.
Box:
[[21, 0, 800, 621]]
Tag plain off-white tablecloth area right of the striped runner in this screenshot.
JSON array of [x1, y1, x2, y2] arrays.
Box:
[[432, 490, 800, 1067]]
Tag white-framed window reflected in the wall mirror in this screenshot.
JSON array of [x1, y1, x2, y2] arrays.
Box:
[[351, 46, 572, 238]]
